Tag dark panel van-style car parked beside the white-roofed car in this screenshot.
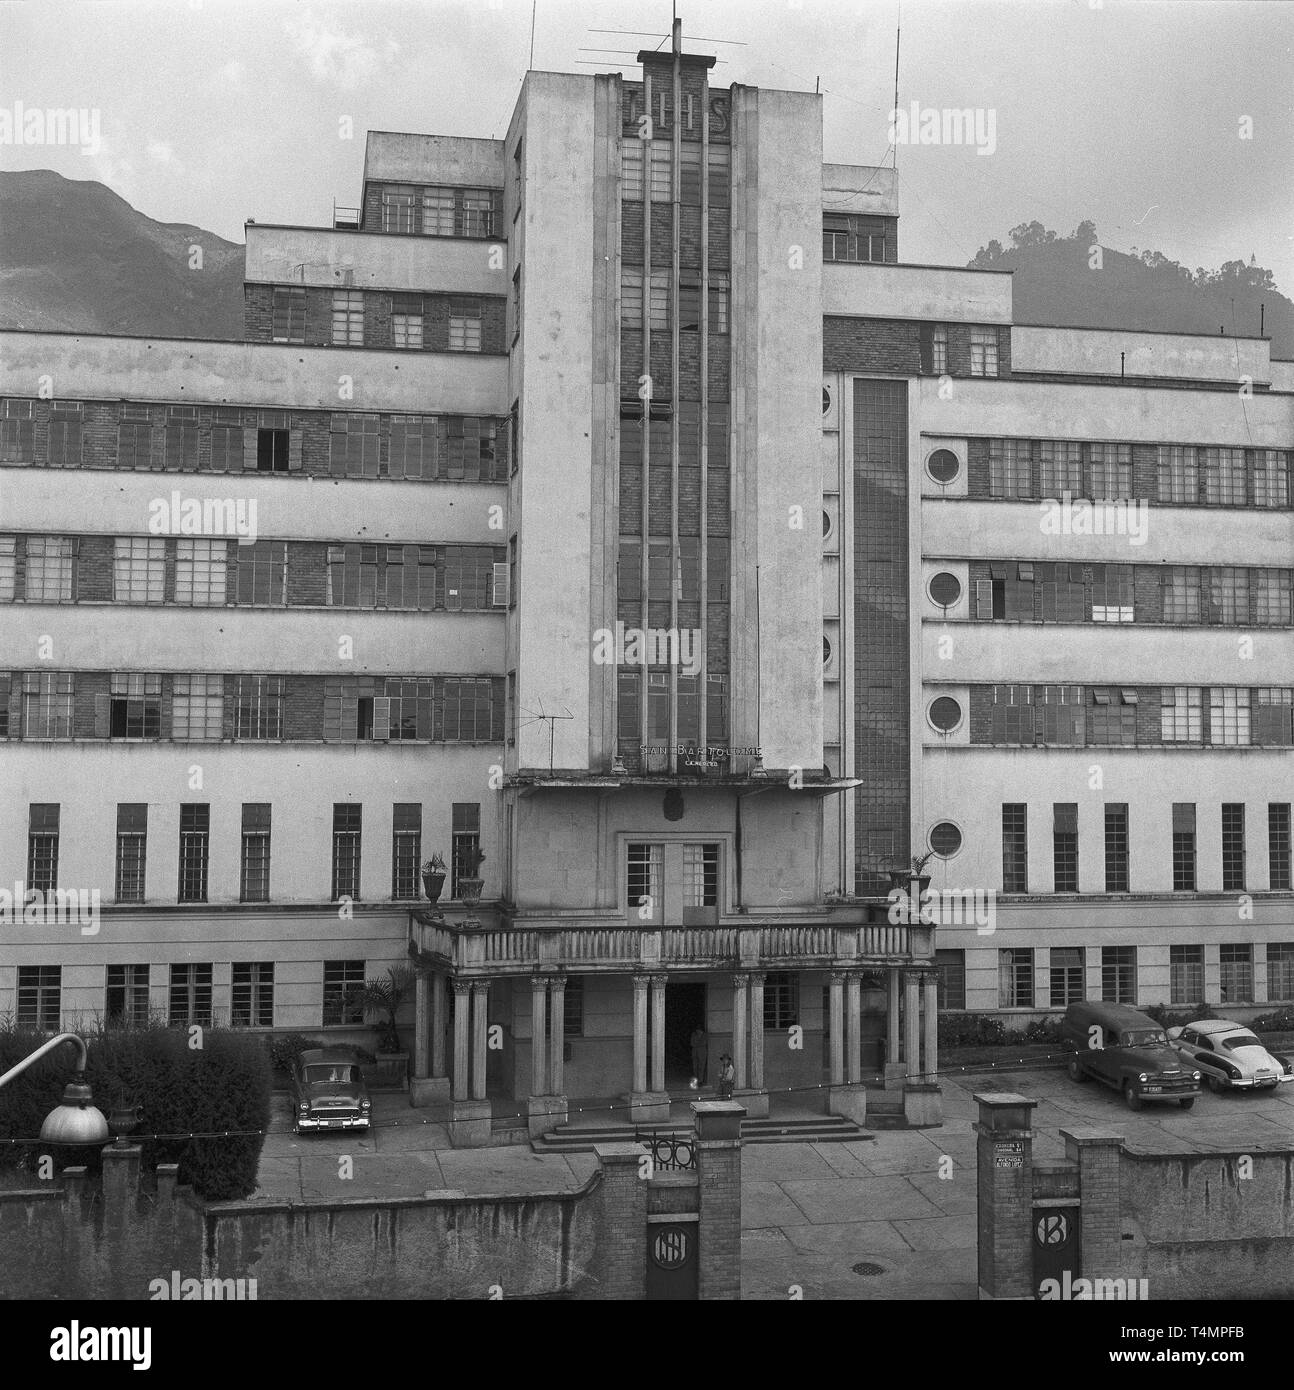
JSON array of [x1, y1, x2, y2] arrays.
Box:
[[1060, 999, 1199, 1111]]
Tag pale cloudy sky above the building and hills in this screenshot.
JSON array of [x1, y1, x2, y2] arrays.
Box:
[[0, 0, 1294, 293]]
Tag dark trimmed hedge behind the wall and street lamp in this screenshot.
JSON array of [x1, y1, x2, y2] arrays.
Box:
[[0, 1026, 271, 1201]]
